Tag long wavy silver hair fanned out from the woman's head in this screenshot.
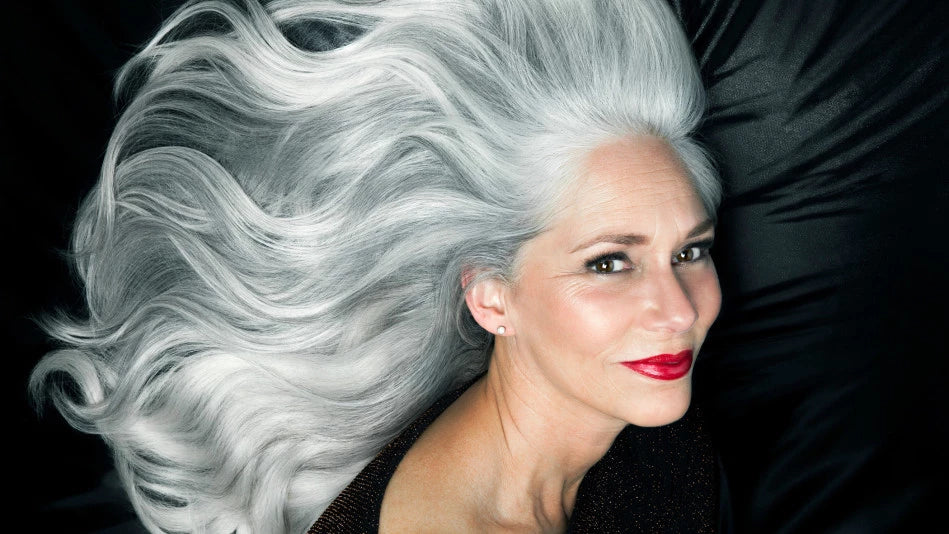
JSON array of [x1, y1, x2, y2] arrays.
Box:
[[30, 0, 721, 533]]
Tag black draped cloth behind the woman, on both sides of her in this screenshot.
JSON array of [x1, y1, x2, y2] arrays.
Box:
[[11, 0, 949, 534]]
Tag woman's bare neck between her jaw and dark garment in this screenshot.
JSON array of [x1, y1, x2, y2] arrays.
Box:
[[472, 347, 626, 531]]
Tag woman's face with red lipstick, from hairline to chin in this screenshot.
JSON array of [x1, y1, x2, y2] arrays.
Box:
[[504, 137, 721, 426]]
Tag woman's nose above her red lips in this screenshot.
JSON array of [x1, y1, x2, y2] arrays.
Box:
[[643, 266, 698, 334]]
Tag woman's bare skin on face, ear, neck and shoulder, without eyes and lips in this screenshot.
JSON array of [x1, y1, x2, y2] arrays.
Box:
[[382, 137, 721, 532]]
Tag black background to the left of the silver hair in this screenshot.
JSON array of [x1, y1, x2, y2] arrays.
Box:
[[0, 0, 180, 532]]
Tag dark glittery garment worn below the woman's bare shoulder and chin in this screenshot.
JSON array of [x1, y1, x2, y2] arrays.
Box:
[[307, 378, 729, 534]]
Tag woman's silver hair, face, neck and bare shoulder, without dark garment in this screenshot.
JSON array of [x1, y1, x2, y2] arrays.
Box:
[[32, 0, 720, 532]]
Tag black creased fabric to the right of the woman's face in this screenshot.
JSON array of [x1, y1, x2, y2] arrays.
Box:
[[674, 0, 949, 534]]
